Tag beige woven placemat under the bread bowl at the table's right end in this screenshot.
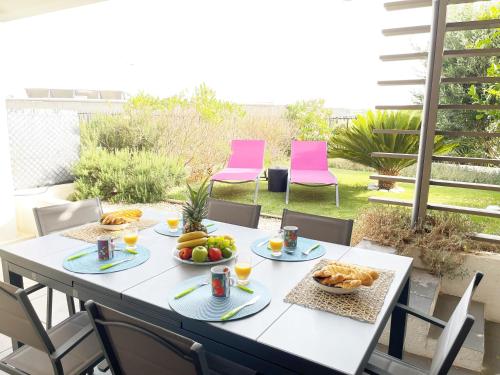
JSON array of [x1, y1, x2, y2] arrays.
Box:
[[285, 259, 394, 323]]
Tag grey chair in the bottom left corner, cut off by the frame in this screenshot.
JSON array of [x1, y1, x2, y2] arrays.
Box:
[[0, 281, 103, 375]]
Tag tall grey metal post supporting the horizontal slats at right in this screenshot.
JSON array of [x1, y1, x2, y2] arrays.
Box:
[[412, 0, 447, 226]]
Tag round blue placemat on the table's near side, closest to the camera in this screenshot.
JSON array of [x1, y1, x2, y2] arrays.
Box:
[[168, 274, 271, 322]]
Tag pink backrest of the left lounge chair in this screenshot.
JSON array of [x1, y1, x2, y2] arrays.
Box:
[[227, 139, 266, 169]]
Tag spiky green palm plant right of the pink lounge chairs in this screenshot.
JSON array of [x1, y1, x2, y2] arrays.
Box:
[[329, 111, 456, 189]]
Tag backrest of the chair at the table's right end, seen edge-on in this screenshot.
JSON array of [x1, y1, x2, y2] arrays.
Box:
[[429, 272, 483, 375]]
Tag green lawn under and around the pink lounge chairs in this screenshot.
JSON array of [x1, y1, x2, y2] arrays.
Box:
[[166, 169, 500, 234]]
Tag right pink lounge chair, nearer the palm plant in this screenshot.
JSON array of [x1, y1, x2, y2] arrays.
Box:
[[286, 141, 339, 207]]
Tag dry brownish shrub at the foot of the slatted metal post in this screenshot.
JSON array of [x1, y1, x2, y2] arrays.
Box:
[[353, 206, 500, 279]]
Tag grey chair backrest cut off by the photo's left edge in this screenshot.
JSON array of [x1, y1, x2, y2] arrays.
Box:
[[0, 281, 54, 354]]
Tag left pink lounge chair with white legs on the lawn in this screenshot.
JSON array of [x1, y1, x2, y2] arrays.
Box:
[[208, 140, 266, 203]]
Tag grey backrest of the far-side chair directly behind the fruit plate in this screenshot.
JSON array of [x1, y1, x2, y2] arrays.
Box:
[[207, 199, 261, 228]]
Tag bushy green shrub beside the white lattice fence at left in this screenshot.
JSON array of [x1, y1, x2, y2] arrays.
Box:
[[73, 148, 185, 203]]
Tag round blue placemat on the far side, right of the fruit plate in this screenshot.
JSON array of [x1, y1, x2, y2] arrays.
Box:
[[251, 237, 326, 262]]
